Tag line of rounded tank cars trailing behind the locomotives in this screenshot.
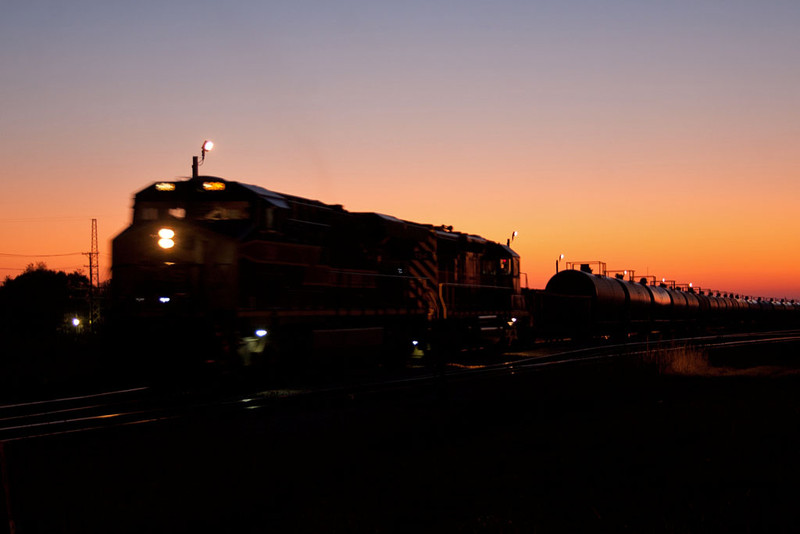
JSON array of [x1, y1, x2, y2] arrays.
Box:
[[530, 265, 800, 338]]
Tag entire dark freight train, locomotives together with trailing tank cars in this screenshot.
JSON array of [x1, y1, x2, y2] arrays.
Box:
[[111, 168, 800, 367]]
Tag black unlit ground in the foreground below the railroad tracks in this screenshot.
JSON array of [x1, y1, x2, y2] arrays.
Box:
[[0, 347, 800, 533]]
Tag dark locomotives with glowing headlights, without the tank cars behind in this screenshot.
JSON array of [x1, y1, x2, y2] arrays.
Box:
[[112, 173, 528, 372]]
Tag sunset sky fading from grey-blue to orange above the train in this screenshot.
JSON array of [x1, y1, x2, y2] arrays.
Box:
[[0, 0, 800, 298]]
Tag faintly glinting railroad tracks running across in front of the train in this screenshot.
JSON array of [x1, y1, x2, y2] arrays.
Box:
[[0, 330, 800, 444]]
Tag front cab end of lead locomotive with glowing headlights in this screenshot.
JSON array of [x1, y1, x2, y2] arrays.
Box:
[[112, 177, 255, 316]]
